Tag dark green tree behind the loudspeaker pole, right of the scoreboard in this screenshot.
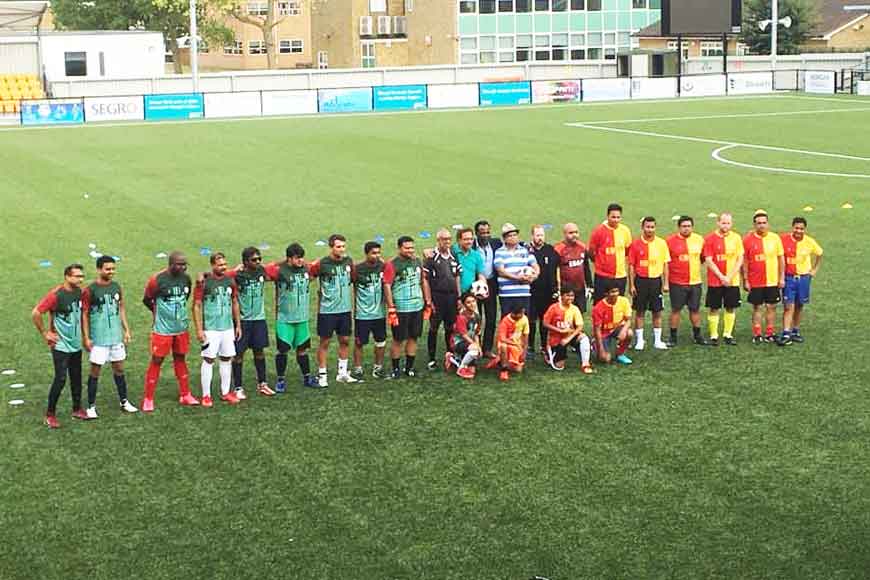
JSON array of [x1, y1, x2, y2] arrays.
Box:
[[740, 0, 819, 54]]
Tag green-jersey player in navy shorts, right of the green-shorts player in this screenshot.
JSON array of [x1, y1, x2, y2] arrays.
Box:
[[311, 234, 357, 388]]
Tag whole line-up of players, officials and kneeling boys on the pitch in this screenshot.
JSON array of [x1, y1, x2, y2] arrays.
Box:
[[32, 204, 822, 428]]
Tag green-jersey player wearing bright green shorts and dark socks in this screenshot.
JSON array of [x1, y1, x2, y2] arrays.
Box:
[[265, 243, 320, 393]]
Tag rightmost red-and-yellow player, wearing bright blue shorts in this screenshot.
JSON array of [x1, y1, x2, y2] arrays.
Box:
[[780, 217, 824, 344]]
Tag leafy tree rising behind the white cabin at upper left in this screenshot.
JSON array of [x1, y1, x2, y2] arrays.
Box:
[[51, 0, 232, 73]]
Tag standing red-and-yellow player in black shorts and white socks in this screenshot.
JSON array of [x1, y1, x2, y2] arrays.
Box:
[[628, 216, 671, 350]]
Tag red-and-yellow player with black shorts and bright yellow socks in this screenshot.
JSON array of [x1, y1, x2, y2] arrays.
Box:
[[702, 213, 743, 346]]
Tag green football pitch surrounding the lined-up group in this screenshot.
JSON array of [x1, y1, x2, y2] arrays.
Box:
[[0, 94, 870, 580]]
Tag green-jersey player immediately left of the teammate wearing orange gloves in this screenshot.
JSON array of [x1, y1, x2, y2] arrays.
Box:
[[351, 242, 387, 381]]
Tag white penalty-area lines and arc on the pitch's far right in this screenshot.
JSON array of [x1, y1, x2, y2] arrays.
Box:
[[566, 106, 870, 179]]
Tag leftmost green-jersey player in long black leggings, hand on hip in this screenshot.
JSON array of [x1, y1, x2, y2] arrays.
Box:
[[30, 264, 88, 429]]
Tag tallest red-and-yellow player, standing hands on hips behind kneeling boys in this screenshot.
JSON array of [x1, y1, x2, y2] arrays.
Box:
[[586, 203, 631, 303]]
